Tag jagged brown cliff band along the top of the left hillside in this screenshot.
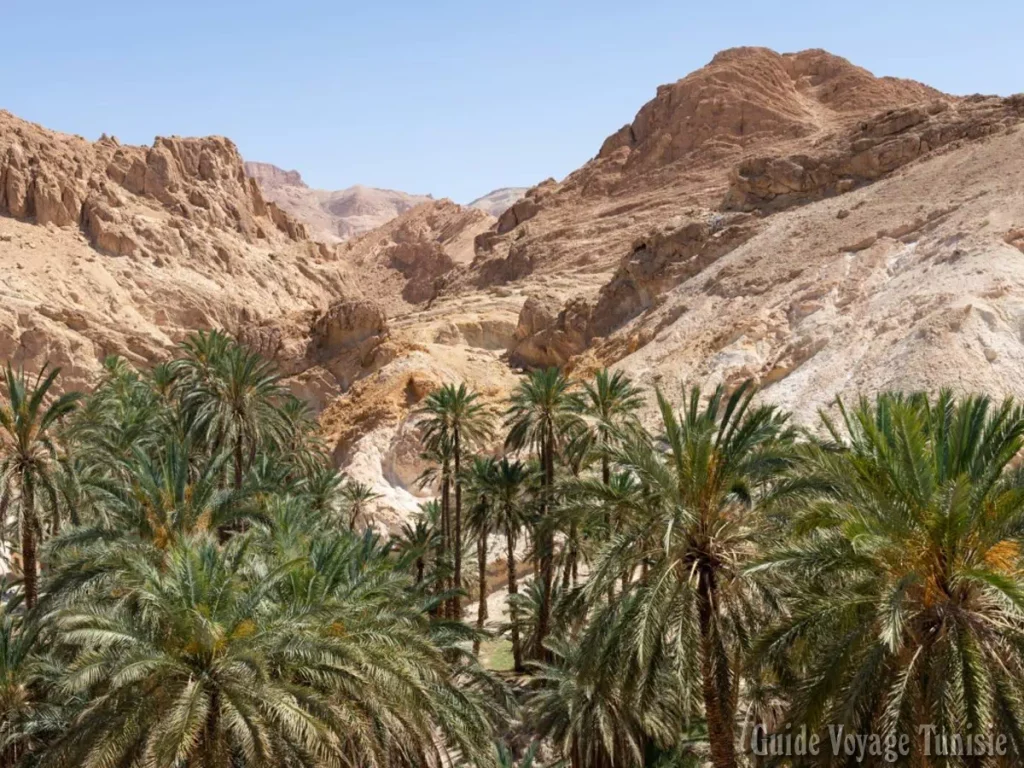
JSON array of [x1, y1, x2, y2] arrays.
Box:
[[0, 113, 307, 257]]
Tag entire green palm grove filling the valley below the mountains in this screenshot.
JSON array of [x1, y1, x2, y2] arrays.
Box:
[[0, 332, 1024, 768]]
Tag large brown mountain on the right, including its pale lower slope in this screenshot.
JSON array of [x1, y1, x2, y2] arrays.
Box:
[[324, 48, 1024, 524]]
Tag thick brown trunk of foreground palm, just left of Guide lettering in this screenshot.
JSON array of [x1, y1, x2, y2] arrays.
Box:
[[697, 565, 736, 768]]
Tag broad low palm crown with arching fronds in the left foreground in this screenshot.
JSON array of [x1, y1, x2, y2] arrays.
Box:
[[47, 536, 499, 766]]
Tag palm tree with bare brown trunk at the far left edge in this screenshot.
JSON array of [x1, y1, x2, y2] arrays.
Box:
[[0, 365, 80, 608]]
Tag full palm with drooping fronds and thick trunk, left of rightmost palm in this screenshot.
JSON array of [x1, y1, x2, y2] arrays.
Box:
[[589, 382, 793, 768]]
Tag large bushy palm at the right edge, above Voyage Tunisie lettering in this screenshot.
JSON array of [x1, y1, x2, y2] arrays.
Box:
[[755, 391, 1024, 765]]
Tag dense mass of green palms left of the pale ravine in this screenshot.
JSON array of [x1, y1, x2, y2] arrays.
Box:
[[0, 333, 510, 768]]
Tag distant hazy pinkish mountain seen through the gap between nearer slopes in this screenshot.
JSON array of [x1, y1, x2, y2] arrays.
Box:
[[245, 162, 431, 243]]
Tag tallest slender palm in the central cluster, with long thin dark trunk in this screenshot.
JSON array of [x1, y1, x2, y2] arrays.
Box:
[[505, 368, 579, 653]]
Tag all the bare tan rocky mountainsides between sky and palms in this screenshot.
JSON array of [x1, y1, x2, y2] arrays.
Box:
[[0, 48, 1024, 523]]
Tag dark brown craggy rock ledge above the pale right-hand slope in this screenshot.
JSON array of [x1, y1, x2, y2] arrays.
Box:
[[723, 96, 1024, 210]]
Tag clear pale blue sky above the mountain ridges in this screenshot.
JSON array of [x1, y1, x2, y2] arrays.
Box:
[[0, 0, 1024, 202]]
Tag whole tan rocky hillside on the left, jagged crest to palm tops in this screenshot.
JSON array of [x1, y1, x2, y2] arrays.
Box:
[[0, 112, 357, 388]]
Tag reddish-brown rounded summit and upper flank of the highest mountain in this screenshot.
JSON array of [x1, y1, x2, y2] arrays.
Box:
[[452, 48, 956, 294]]
